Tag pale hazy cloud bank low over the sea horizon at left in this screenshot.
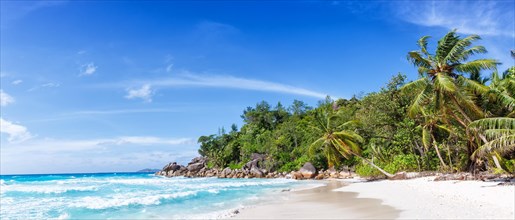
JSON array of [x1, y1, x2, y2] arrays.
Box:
[[0, 136, 198, 174]]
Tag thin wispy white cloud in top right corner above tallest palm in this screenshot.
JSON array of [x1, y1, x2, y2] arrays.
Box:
[[393, 1, 515, 37]]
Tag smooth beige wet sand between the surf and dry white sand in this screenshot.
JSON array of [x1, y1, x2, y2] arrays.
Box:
[[234, 181, 400, 219]]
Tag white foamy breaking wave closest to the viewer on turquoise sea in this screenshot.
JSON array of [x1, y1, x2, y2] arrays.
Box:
[[70, 191, 197, 209]]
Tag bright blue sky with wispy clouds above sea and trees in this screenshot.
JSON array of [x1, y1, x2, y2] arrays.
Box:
[[0, 1, 515, 174]]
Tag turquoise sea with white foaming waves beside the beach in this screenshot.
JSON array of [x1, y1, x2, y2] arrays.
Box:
[[0, 173, 315, 219]]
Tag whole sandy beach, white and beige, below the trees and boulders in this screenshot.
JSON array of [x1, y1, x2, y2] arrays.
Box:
[[234, 177, 515, 219]]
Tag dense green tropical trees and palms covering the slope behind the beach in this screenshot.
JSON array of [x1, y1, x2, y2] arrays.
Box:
[[198, 30, 515, 177]]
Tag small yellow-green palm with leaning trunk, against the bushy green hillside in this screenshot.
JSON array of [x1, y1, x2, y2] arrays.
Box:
[[309, 111, 394, 178]]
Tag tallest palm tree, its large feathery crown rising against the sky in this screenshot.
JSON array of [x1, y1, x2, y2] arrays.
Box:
[[403, 30, 499, 169]]
